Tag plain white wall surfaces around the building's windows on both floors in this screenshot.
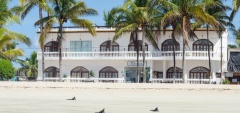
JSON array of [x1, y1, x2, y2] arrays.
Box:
[[38, 30, 228, 79]]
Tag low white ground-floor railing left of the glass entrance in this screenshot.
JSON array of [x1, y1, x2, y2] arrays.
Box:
[[44, 78, 124, 83]]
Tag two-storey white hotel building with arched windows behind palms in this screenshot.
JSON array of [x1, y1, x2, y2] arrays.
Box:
[[38, 27, 228, 83]]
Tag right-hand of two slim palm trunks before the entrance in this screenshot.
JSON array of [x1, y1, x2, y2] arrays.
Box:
[[142, 26, 146, 83]]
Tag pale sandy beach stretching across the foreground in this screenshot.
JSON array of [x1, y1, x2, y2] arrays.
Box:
[[0, 82, 240, 113]]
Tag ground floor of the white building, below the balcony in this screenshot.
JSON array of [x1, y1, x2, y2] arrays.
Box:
[[38, 60, 223, 83]]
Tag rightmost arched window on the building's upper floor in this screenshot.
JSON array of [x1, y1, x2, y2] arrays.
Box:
[[193, 39, 213, 51]]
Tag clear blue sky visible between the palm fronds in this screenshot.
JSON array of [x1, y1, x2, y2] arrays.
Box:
[[8, 0, 240, 67]]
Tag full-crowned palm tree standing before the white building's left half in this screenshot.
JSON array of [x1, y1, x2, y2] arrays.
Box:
[[35, 0, 97, 81]]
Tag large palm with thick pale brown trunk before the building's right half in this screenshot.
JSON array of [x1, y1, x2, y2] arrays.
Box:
[[150, 0, 224, 81]]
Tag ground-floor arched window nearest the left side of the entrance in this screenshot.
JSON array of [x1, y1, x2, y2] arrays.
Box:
[[99, 66, 118, 78]]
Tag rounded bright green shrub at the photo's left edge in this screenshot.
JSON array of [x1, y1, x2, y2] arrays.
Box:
[[0, 59, 15, 80]]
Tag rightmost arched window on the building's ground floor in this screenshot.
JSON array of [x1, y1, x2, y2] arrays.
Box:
[[189, 67, 209, 79]]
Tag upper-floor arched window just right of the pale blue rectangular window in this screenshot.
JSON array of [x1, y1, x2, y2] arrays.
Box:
[[100, 40, 119, 51]]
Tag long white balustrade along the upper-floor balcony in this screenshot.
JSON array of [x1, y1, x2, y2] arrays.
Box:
[[38, 51, 221, 60]]
